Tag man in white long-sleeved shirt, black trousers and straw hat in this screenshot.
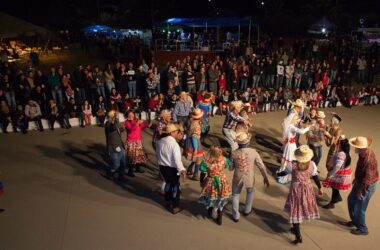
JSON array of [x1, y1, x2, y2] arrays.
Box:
[[156, 123, 186, 214]]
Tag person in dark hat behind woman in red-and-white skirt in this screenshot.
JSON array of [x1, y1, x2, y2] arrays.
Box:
[[324, 112, 342, 171]]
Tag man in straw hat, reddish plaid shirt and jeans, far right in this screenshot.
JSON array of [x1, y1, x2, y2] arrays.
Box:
[[344, 136, 379, 235]]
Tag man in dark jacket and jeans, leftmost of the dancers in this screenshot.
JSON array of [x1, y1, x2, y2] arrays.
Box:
[[105, 110, 126, 182]]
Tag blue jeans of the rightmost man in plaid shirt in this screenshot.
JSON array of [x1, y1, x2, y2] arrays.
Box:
[[347, 183, 376, 232]]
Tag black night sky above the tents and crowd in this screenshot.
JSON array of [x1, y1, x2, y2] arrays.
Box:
[[1, 0, 380, 31]]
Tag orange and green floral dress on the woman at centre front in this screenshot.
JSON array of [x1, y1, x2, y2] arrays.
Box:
[[199, 157, 231, 210]]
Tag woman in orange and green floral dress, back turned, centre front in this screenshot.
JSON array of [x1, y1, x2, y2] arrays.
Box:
[[199, 146, 231, 225]]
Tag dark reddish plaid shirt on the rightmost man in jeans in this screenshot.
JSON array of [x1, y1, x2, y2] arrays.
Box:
[[355, 149, 379, 191]]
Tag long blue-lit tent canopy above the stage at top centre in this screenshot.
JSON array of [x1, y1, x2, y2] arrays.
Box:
[[158, 16, 253, 28]]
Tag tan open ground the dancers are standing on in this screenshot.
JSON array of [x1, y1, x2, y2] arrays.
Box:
[[0, 106, 380, 250]]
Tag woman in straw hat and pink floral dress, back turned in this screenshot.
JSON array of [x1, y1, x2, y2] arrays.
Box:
[[277, 145, 323, 244]]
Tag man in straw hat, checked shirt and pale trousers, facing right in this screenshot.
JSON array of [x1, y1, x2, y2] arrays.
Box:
[[223, 101, 249, 152]]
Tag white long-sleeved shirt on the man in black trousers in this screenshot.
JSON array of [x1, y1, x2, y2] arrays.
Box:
[[156, 135, 186, 172]]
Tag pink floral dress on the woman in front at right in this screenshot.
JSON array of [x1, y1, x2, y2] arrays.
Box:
[[284, 161, 319, 223]]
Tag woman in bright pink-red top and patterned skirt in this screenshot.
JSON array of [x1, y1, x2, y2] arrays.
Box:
[[124, 110, 152, 177]]
